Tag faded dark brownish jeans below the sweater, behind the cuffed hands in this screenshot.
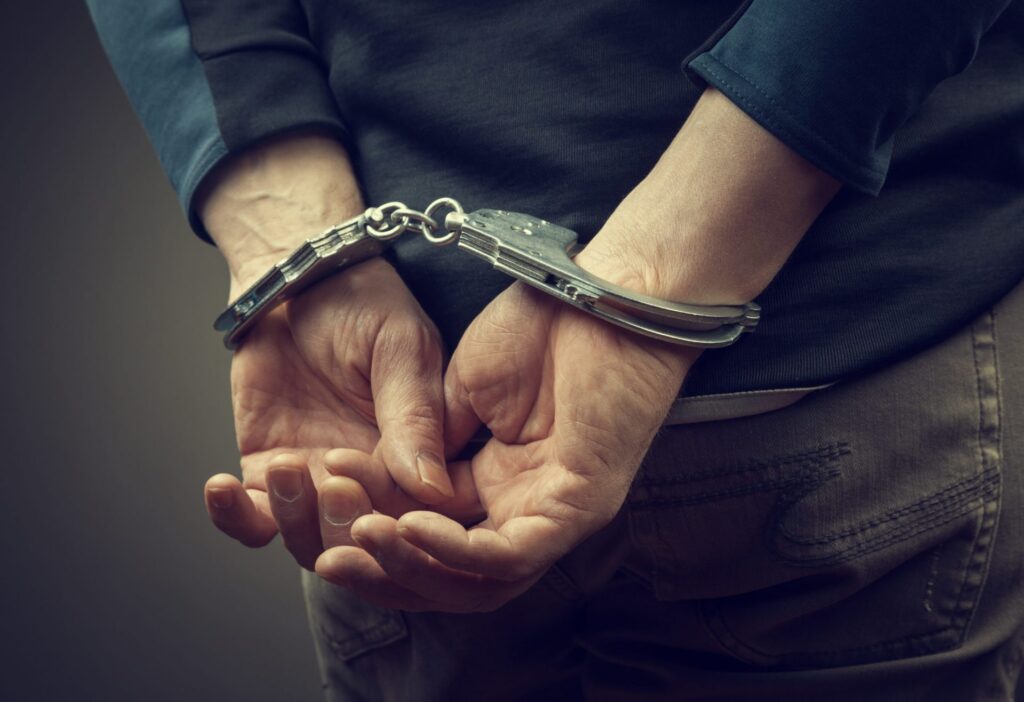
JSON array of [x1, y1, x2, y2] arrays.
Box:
[[304, 287, 1024, 702]]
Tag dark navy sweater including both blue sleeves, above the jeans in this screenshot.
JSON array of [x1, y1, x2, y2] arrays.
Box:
[[89, 0, 1024, 394]]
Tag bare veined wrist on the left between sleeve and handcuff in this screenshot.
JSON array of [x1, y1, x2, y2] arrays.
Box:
[[197, 133, 364, 297]]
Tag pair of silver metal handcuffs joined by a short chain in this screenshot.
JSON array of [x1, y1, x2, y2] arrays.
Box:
[[214, 198, 761, 349]]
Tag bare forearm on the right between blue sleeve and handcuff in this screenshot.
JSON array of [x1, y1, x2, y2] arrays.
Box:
[[577, 89, 840, 303]]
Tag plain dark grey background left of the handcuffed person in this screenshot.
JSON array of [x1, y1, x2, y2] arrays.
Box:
[[0, 0, 319, 702]]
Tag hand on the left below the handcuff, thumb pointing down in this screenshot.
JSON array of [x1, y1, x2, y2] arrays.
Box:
[[206, 259, 478, 569]]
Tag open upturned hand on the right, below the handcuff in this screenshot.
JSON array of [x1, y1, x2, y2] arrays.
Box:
[[316, 274, 697, 612]]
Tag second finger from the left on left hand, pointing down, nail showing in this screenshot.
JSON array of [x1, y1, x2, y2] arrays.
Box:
[[266, 456, 324, 570]]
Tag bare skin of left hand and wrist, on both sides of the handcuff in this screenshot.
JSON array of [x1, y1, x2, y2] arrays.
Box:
[[200, 134, 479, 568]]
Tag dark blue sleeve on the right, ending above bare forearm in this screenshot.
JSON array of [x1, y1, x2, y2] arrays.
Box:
[[683, 0, 1010, 194]]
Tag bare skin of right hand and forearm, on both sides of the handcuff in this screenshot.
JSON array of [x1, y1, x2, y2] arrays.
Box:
[[316, 90, 839, 612]]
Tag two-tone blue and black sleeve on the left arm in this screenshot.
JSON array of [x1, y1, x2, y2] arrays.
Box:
[[86, 0, 347, 238]]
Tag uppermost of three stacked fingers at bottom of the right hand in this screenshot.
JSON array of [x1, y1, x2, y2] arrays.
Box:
[[397, 512, 571, 581]]
